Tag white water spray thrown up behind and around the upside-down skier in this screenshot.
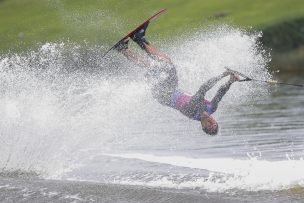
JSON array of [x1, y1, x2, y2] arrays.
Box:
[[0, 26, 288, 192]]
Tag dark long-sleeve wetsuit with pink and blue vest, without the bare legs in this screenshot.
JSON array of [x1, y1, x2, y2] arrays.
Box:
[[150, 64, 232, 120]]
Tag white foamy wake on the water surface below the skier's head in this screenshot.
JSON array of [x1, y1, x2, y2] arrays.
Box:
[[105, 154, 304, 192]]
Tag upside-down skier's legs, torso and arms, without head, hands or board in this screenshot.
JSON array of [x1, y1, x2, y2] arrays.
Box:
[[123, 45, 233, 120]]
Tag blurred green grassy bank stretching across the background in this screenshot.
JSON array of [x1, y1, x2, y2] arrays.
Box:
[[0, 0, 304, 70]]
